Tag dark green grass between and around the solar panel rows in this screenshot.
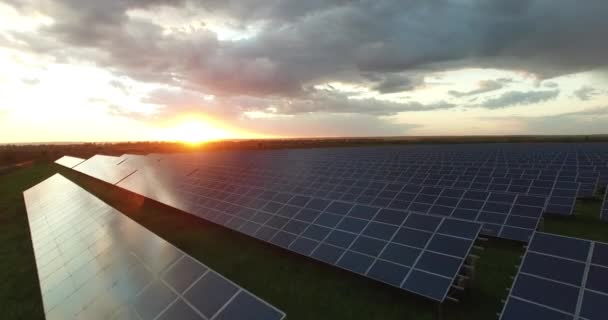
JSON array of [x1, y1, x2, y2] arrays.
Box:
[[0, 163, 608, 320]]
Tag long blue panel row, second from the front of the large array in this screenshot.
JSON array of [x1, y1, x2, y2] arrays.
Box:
[[181, 167, 546, 242]]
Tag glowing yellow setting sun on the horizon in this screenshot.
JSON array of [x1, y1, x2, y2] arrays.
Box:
[[165, 119, 234, 146]]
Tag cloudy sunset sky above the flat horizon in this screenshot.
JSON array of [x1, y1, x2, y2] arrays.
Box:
[[0, 0, 608, 143]]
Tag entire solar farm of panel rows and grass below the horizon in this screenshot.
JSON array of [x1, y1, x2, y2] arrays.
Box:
[[3, 143, 608, 320]]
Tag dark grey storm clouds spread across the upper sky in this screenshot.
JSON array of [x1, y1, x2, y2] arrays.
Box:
[[5, 0, 608, 115]]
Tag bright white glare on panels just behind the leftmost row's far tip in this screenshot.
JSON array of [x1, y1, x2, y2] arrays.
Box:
[[73, 155, 136, 184]]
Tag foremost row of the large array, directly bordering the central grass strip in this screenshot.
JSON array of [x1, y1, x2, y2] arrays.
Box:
[[60, 156, 481, 301]]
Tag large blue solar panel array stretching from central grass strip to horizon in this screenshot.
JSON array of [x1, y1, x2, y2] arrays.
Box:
[[59, 144, 608, 301]]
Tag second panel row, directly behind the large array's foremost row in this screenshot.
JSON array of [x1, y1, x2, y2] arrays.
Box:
[[182, 170, 546, 241]]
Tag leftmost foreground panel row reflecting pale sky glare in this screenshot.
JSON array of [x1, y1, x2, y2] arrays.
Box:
[[24, 175, 284, 320]]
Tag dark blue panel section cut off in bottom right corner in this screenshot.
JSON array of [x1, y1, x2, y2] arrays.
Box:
[[500, 233, 608, 320]]
